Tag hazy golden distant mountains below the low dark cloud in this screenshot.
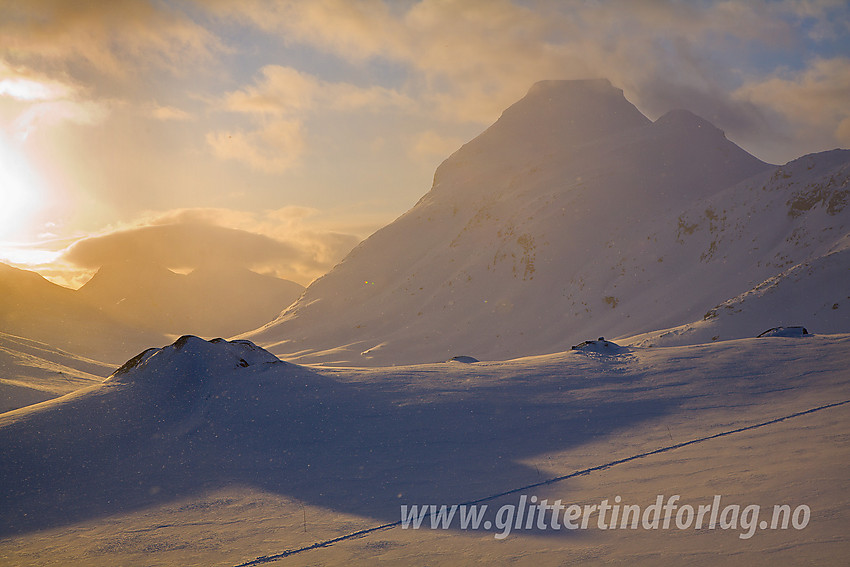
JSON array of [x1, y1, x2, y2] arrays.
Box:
[[0, 261, 304, 364]]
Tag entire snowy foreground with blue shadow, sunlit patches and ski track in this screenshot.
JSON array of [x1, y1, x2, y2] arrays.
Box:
[[0, 334, 850, 566]]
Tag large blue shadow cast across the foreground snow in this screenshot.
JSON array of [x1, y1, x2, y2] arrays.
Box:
[[0, 363, 676, 536]]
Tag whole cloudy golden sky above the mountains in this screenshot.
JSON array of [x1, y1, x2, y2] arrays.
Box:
[[0, 0, 850, 287]]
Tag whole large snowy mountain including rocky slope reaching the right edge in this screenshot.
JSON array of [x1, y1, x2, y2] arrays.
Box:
[[245, 81, 850, 365]]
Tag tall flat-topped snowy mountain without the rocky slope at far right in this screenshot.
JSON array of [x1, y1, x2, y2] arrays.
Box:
[[245, 82, 843, 365]]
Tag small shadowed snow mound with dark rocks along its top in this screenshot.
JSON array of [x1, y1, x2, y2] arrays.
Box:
[[106, 335, 282, 383]]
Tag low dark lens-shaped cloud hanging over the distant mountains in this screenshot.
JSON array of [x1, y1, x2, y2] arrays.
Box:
[[62, 208, 359, 284]]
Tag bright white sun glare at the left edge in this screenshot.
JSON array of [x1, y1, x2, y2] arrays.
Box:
[[0, 133, 42, 240]]
